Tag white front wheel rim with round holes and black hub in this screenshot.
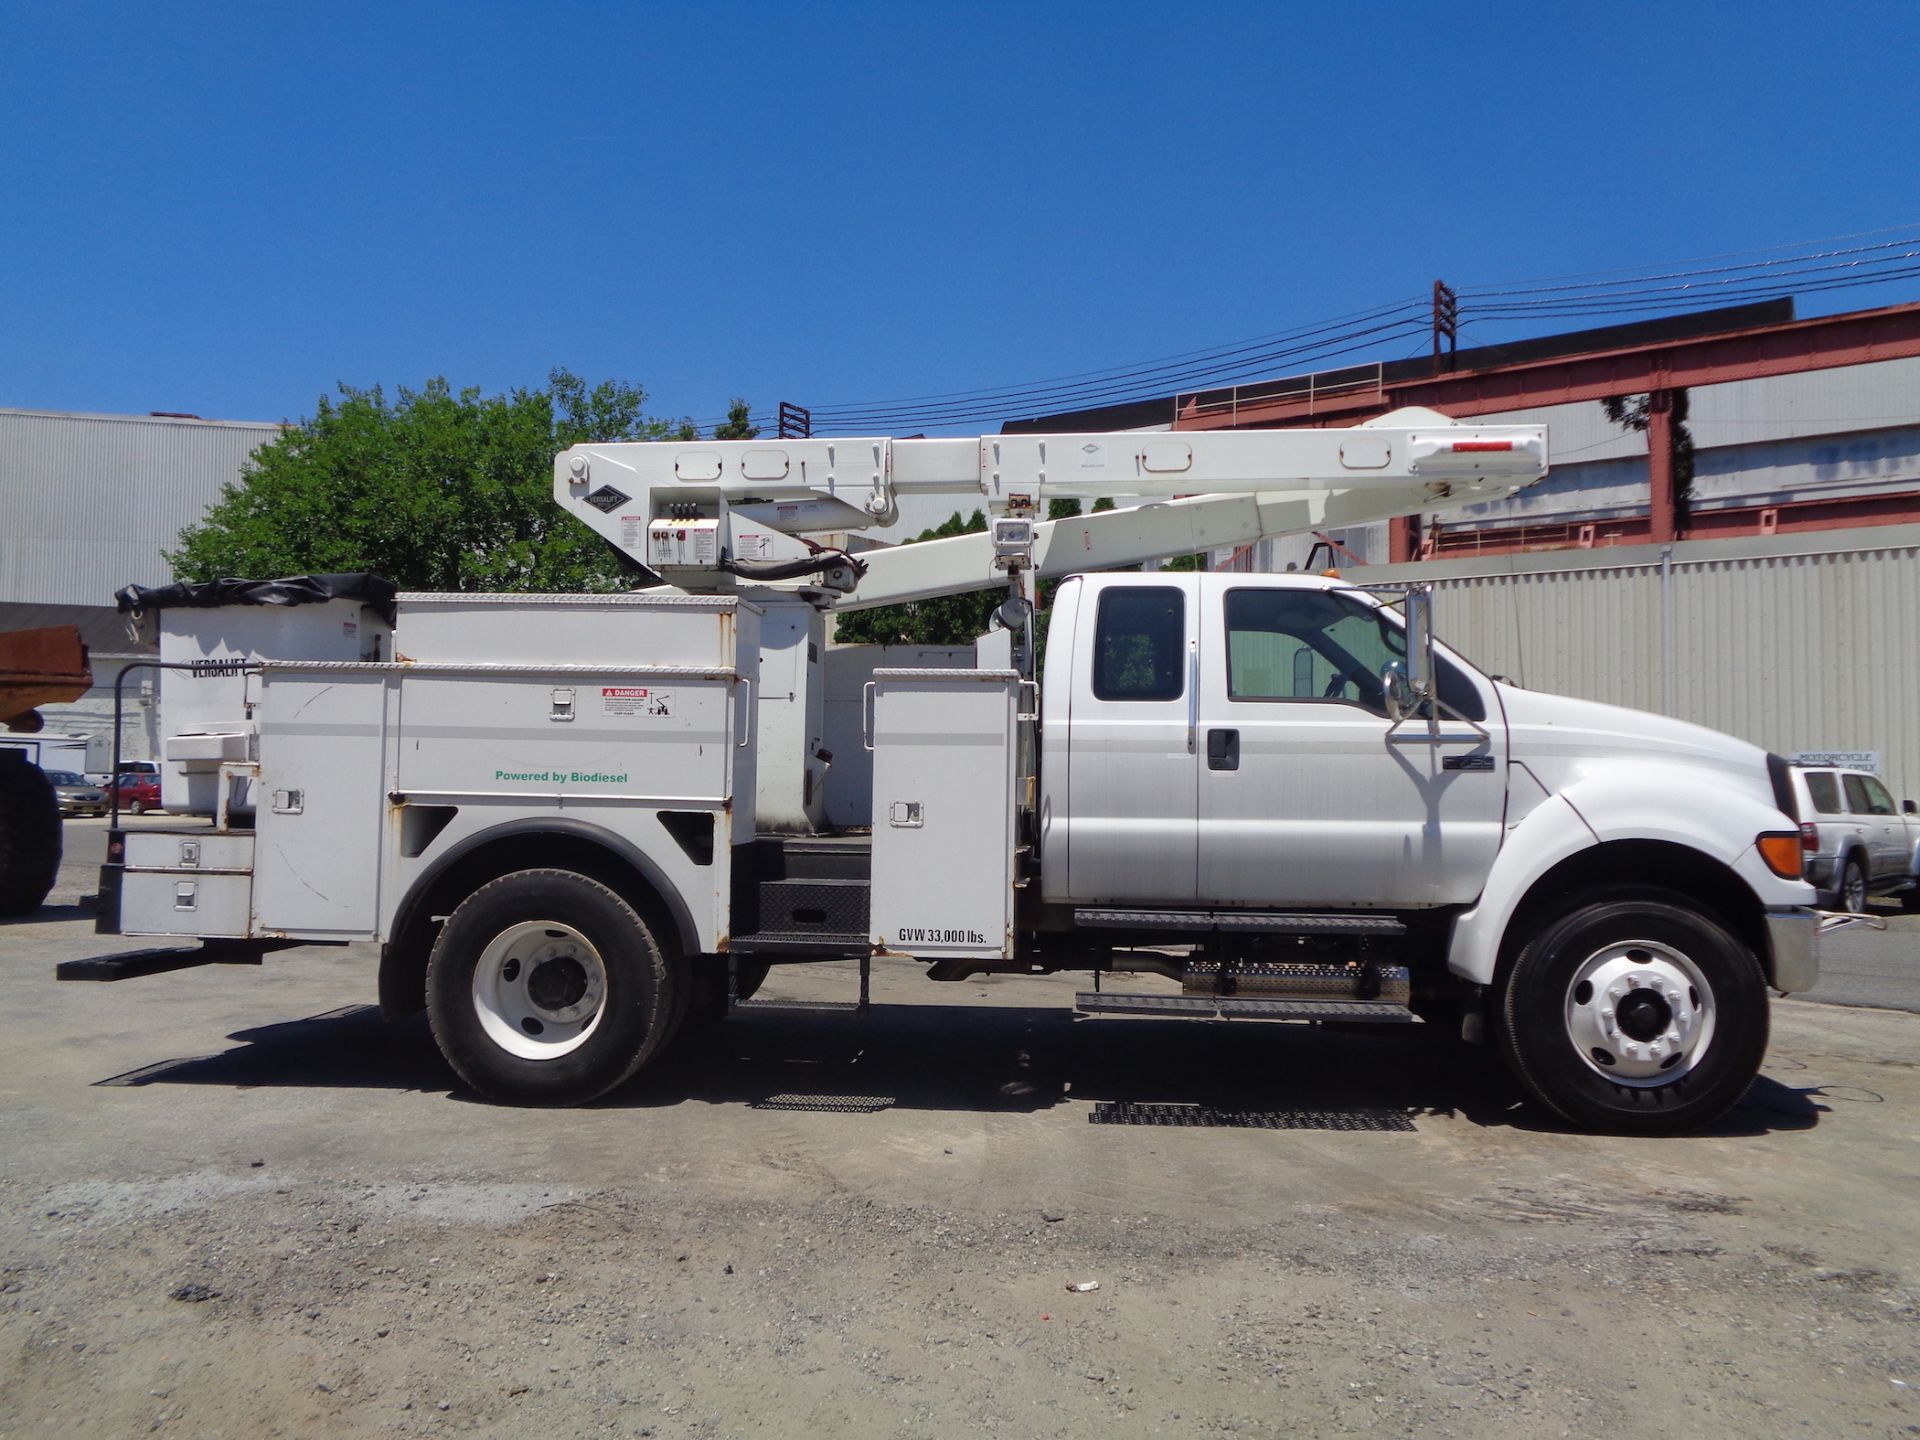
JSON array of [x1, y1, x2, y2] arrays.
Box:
[[1565, 941, 1715, 1089]]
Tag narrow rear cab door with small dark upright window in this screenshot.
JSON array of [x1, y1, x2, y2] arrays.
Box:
[[1048, 574, 1198, 904]]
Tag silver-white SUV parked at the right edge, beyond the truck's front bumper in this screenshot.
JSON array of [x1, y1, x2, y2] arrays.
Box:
[[1793, 766, 1920, 914]]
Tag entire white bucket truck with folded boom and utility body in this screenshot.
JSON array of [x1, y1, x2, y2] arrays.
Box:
[[78, 411, 1816, 1131]]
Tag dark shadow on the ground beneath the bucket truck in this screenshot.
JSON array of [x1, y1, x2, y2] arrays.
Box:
[[98, 1004, 1826, 1137]]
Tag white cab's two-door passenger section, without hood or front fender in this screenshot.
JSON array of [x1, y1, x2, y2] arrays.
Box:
[[1043, 574, 1507, 910]]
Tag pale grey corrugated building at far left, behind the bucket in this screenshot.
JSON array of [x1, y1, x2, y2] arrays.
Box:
[[0, 409, 280, 770]]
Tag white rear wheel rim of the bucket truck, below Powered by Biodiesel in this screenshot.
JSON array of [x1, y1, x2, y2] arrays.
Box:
[[472, 920, 607, 1060]]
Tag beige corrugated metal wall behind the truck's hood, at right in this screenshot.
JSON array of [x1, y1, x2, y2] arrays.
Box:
[[1348, 524, 1920, 799]]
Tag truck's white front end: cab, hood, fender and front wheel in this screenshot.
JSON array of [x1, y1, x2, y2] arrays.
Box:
[[1037, 574, 1816, 1127]]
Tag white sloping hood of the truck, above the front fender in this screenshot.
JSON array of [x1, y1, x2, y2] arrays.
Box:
[[1496, 682, 1774, 806]]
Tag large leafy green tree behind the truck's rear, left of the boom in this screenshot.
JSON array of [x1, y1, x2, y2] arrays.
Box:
[[167, 371, 699, 589]]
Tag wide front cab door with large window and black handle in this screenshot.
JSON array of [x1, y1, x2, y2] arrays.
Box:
[[1194, 574, 1507, 910]]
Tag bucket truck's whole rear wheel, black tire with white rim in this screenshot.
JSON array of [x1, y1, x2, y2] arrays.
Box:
[[426, 870, 682, 1106]]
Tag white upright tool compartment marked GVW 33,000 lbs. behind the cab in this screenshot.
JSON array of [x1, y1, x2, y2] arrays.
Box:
[[872, 670, 1020, 960]]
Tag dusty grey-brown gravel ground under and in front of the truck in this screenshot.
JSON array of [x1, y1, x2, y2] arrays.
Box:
[[0, 821, 1920, 1438]]
